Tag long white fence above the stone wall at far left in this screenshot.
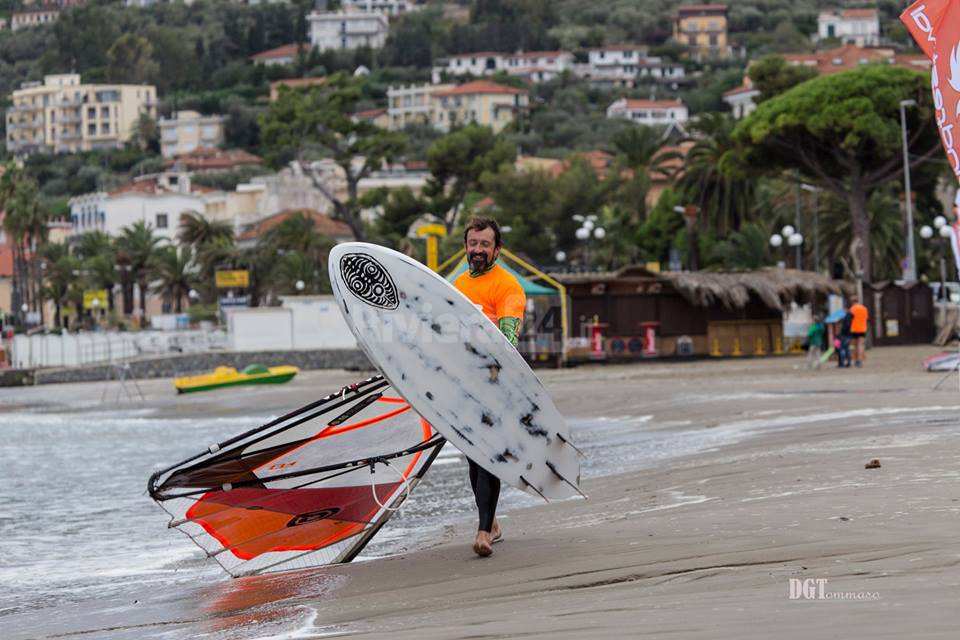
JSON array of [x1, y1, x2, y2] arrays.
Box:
[[9, 331, 227, 368]]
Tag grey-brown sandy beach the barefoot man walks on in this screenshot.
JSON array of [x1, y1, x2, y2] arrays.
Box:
[[0, 347, 960, 639]]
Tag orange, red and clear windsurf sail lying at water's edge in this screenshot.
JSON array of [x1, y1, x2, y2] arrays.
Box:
[[148, 376, 445, 576]]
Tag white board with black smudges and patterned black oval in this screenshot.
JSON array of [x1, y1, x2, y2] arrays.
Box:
[[329, 242, 580, 498]]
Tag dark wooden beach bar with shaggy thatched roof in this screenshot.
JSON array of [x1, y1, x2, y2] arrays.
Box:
[[554, 266, 843, 362]]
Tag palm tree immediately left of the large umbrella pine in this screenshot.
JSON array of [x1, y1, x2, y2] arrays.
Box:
[[677, 114, 756, 235]]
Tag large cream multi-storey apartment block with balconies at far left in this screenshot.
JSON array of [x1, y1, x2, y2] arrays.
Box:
[[6, 73, 157, 156]]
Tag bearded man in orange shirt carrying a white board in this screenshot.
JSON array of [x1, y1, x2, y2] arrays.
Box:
[[453, 218, 527, 557]]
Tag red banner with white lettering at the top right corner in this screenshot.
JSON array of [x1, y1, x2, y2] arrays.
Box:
[[900, 0, 960, 180]]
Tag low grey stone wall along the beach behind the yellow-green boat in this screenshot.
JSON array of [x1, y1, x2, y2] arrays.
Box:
[[0, 349, 374, 387]]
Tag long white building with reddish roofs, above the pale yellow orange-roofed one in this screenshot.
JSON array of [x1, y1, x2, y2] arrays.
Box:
[[433, 51, 574, 84]]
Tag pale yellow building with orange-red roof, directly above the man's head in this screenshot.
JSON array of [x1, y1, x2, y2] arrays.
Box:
[[433, 80, 530, 133]]
